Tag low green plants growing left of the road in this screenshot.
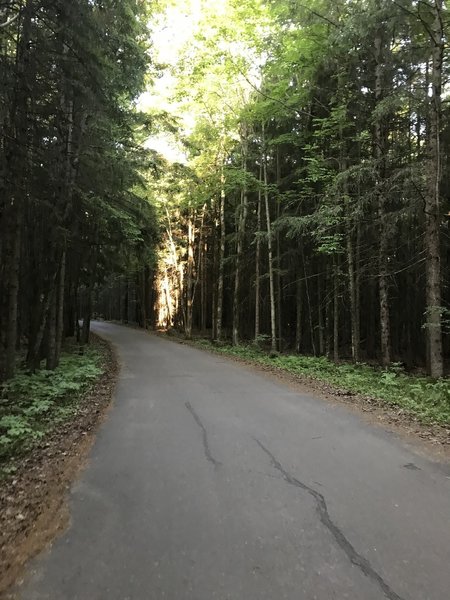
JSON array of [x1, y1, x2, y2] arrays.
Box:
[[0, 346, 103, 474]]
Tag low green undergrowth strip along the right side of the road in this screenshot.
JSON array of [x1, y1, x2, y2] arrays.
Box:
[[196, 340, 450, 425]]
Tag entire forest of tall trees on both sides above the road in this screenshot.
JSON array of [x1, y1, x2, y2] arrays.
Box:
[[0, 0, 450, 379]]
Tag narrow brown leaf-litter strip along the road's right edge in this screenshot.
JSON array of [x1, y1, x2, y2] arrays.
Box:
[[160, 331, 450, 462]]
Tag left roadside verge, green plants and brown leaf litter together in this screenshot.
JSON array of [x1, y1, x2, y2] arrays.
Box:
[[0, 337, 118, 598]]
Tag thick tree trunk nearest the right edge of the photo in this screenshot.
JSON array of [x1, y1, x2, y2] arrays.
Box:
[[425, 0, 445, 378]]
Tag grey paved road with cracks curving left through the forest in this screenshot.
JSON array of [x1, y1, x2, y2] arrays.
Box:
[[21, 323, 450, 600]]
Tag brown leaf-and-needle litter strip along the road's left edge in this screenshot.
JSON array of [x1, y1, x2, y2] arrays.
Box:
[[0, 336, 118, 598]]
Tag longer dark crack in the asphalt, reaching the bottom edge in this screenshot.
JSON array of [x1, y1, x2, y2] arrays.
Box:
[[253, 438, 404, 600]]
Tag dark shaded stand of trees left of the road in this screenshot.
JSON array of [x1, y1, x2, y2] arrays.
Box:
[[0, 0, 157, 379]]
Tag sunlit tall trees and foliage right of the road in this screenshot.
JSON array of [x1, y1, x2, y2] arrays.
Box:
[[143, 0, 449, 377]]
